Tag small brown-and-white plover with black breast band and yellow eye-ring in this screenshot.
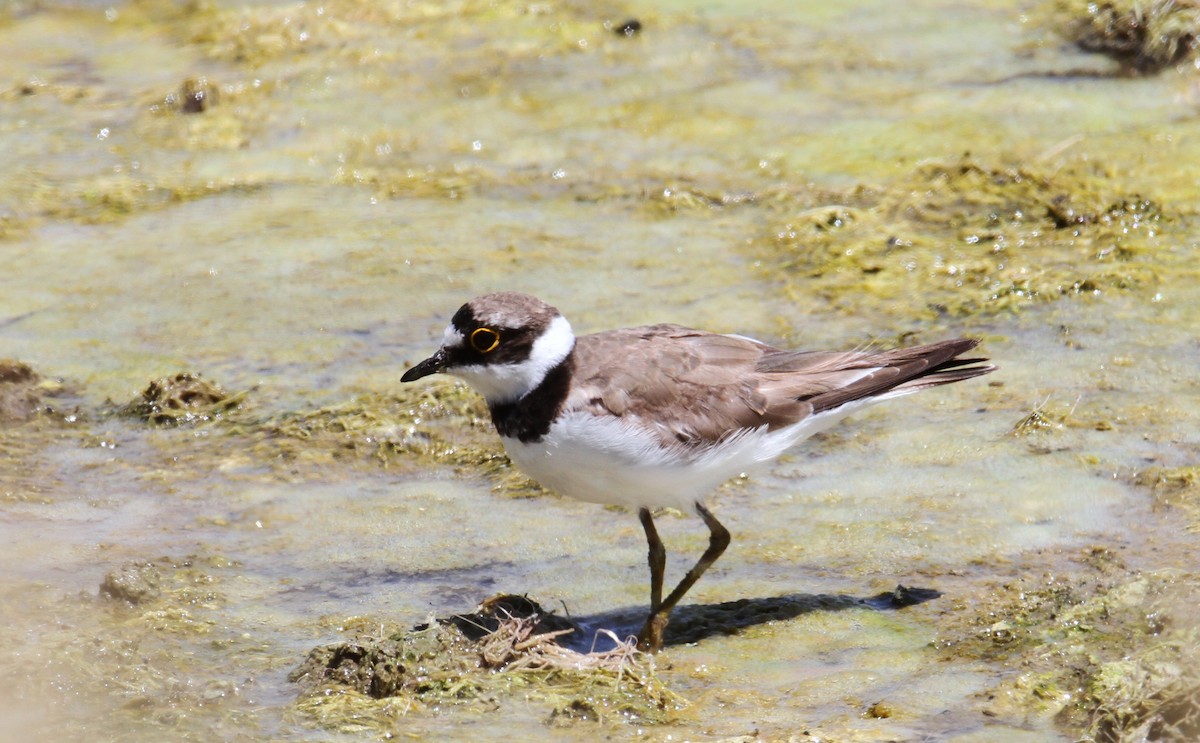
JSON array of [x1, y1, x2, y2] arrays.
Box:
[[401, 292, 995, 652]]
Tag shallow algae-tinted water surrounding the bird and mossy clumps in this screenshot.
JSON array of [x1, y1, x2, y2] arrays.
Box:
[[0, 1, 1200, 741]]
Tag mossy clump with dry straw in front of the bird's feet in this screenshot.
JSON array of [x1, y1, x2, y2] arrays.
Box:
[[289, 595, 683, 729]]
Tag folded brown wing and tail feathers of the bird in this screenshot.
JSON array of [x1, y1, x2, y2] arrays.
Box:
[[566, 324, 992, 447]]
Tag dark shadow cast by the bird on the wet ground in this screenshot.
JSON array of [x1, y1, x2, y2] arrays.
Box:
[[446, 586, 942, 653]]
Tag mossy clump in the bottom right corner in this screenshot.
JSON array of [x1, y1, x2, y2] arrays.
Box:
[[937, 546, 1200, 743]]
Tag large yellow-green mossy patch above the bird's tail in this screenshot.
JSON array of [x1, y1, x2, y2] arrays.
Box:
[[763, 156, 1163, 317]]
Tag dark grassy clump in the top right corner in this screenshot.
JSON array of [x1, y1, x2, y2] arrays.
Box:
[[1048, 0, 1200, 74]]
